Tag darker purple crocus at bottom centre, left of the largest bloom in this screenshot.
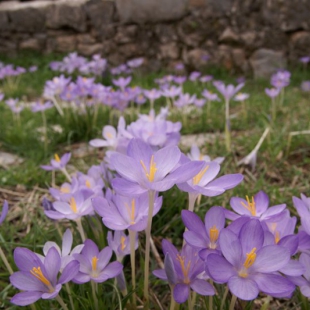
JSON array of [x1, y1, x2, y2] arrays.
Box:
[[153, 239, 214, 304]]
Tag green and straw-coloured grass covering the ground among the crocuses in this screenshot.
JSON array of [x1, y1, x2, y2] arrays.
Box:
[[0, 49, 310, 309]]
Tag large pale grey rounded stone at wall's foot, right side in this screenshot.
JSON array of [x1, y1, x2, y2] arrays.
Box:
[[250, 48, 286, 78]]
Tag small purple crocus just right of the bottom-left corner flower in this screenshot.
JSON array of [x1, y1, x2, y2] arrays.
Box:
[[73, 239, 123, 284]]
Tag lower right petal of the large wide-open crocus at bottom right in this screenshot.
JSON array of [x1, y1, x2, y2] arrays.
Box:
[[254, 273, 295, 297]]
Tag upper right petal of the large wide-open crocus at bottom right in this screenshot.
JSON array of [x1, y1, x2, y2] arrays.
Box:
[[252, 245, 290, 273]]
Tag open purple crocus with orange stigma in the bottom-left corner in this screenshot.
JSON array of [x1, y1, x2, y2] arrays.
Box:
[[10, 247, 79, 306]]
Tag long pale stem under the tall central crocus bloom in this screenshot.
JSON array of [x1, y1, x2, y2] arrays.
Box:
[[144, 190, 155, 306]]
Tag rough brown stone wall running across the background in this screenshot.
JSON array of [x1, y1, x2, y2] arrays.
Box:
[[0, 0, 310, 76]]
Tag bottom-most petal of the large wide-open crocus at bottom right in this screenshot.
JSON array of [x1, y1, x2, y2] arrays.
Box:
[[228, 276, 259, 300]]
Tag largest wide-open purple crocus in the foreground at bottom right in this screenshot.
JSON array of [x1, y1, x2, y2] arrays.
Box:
[[206, 219, 295, 300]]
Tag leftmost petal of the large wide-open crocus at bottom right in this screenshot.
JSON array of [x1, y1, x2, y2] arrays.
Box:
[[206, 254, 237, 283]]
